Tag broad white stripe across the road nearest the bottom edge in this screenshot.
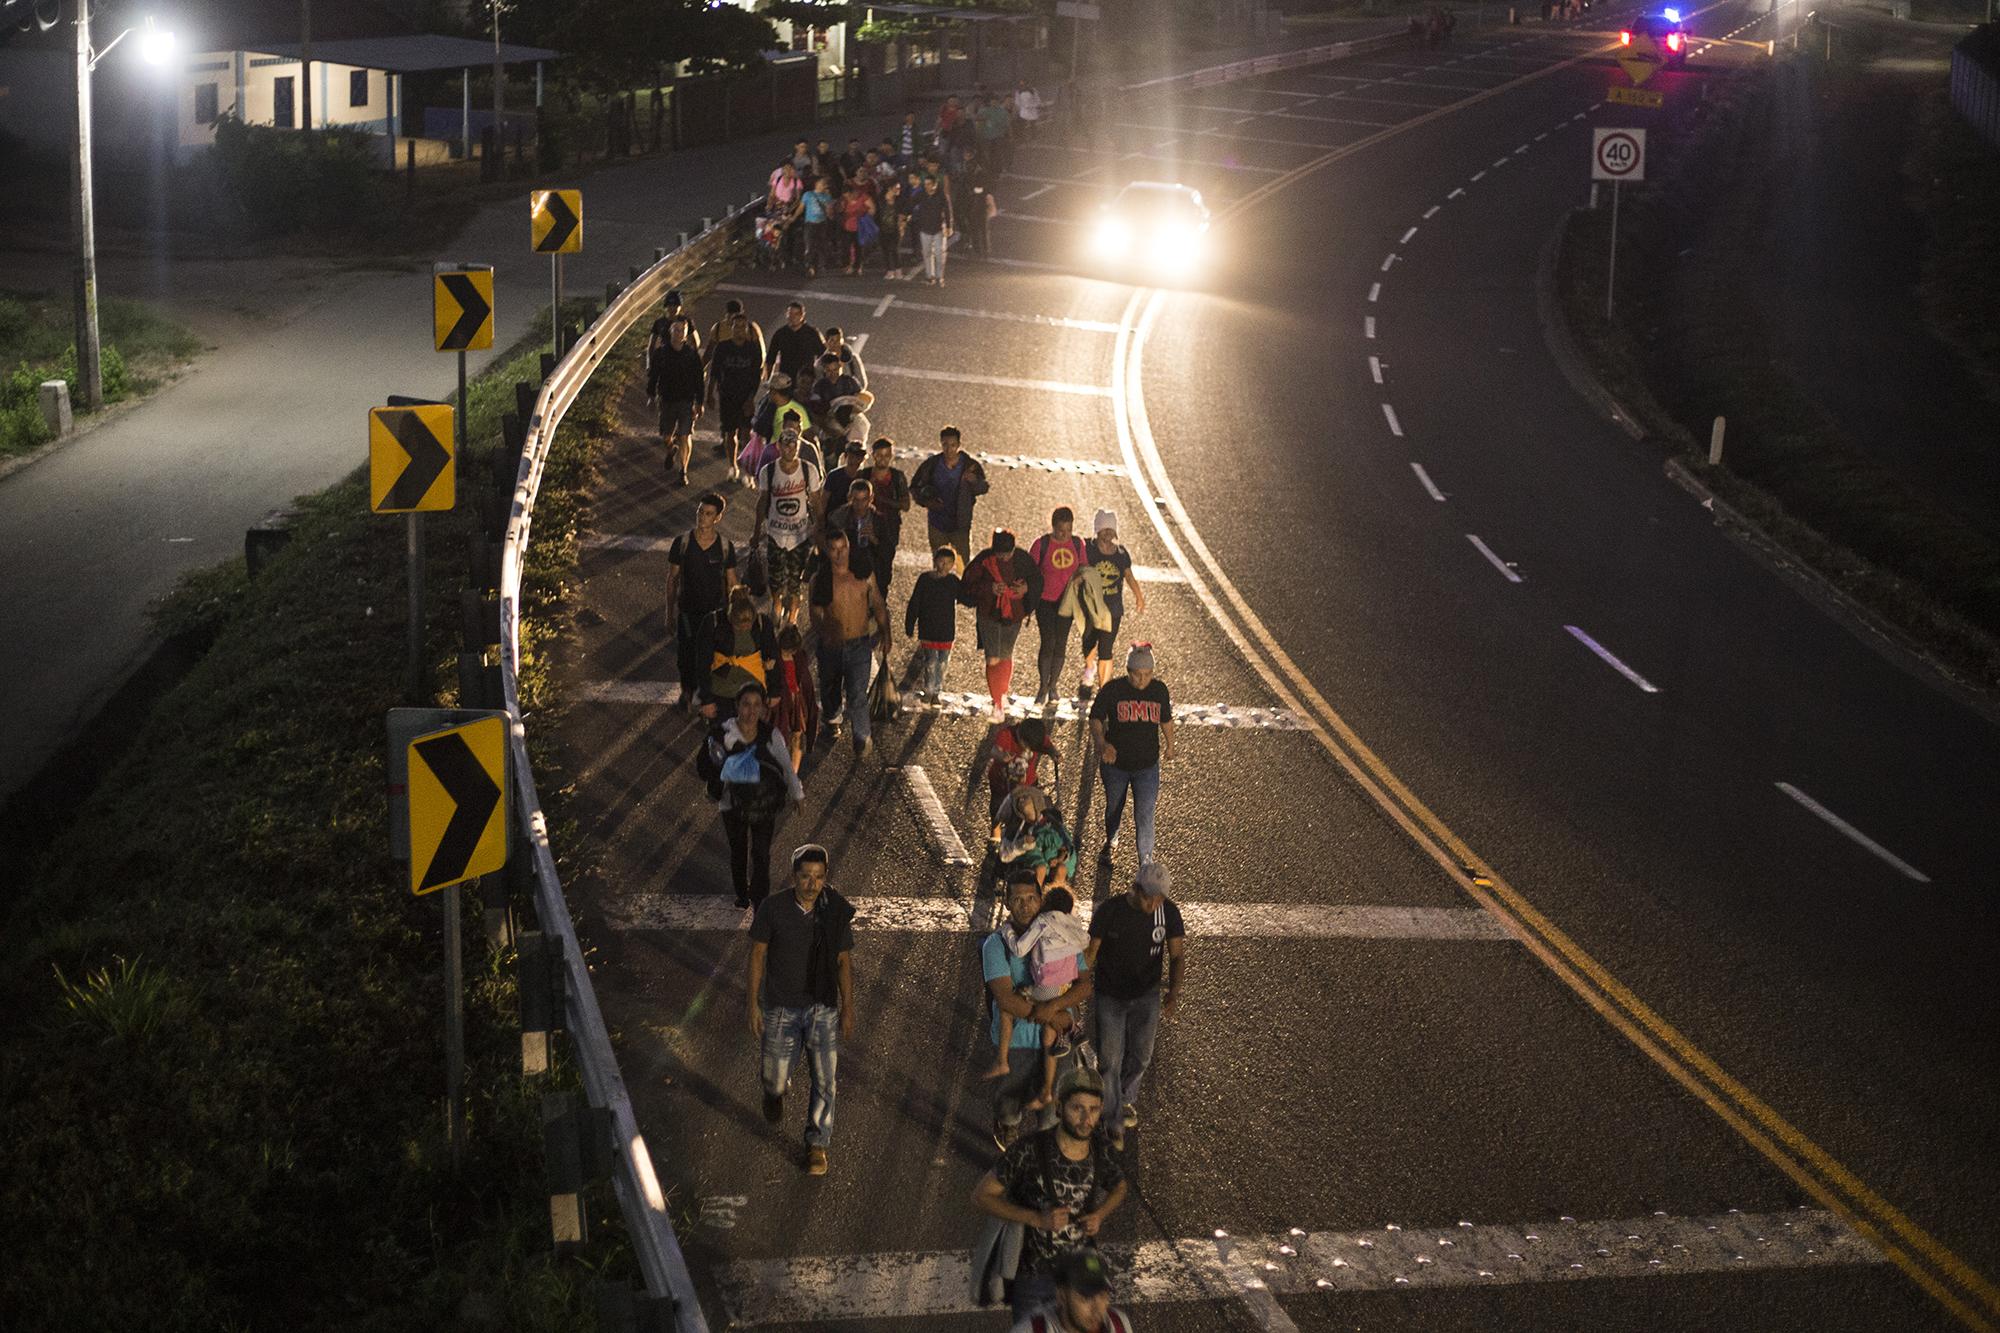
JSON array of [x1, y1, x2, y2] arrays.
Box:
[[716, 1200, 1882, 1329]]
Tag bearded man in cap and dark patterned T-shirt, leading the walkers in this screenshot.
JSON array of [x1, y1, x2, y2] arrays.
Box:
[[972, 1040, 1130, 1321]]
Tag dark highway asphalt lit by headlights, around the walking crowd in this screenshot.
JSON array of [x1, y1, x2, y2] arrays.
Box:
[[562, 4, 2000, 1329]]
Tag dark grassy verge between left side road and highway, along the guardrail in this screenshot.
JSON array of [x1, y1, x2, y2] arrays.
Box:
[[0, 308, 634, 1331]]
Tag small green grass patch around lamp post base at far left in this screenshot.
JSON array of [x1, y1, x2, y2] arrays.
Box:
[[0, 292, 202, 458]]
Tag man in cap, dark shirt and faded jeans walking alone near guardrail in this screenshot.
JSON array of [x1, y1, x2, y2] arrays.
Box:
[[750, 843, 854, 1175]]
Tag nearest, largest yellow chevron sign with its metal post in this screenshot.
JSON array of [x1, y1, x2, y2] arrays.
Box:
[[392, 713, 508, 1167]]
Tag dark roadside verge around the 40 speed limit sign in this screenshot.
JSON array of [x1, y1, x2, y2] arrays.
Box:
[[1556, 57, 2000, 691]]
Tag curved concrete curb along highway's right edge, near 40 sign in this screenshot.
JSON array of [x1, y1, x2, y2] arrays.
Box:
[[1534, 208, 2000, 725]]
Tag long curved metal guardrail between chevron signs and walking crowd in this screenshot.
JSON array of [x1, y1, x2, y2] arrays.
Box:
[[500, 196, 764, 1333]]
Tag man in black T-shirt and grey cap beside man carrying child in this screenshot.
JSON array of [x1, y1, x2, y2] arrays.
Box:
[[1084, 861, 1188, 1149]]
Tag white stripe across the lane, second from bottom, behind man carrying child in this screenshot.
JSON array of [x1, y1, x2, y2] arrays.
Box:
[[606, 888, 1514, 945]]
